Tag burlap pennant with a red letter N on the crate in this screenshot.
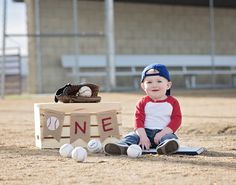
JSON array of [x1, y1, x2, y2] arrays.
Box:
[[70, 113, 90, 143]]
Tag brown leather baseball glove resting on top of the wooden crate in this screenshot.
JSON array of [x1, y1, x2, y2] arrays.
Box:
[[54, 83, 101, 103]]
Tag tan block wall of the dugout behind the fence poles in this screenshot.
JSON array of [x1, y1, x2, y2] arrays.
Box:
[[26, 0, 236, 93]]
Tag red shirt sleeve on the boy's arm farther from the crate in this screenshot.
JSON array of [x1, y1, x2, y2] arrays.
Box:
[[167, 98, 182, 133]]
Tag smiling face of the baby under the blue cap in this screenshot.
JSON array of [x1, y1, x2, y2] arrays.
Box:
[[141, 69, 171, 100]]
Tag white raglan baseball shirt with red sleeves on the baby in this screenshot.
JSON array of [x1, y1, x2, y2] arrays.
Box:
[[134, 96, 182, 133]]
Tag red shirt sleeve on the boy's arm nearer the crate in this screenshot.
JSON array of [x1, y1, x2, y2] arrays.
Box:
[[134, 98, 146, 129]]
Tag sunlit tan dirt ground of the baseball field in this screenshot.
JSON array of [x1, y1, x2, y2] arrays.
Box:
[[0, 90, 236, 185]]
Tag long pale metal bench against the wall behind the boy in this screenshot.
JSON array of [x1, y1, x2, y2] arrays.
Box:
[[61, 55, 236, 88]]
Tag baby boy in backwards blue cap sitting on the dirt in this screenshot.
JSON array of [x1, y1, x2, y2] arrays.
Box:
[[104, 64, 182, 155]]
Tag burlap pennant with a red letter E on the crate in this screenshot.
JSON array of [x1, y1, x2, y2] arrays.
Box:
[[97, 110, 119, 141]]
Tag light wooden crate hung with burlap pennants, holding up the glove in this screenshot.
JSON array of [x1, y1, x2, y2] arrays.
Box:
[[34, 103, 122, 149]]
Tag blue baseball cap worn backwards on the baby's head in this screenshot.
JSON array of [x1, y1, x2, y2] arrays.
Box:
[[141, 64, 170, 95]]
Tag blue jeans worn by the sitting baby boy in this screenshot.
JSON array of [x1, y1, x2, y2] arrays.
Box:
[[118, 128, 178, 148]]
